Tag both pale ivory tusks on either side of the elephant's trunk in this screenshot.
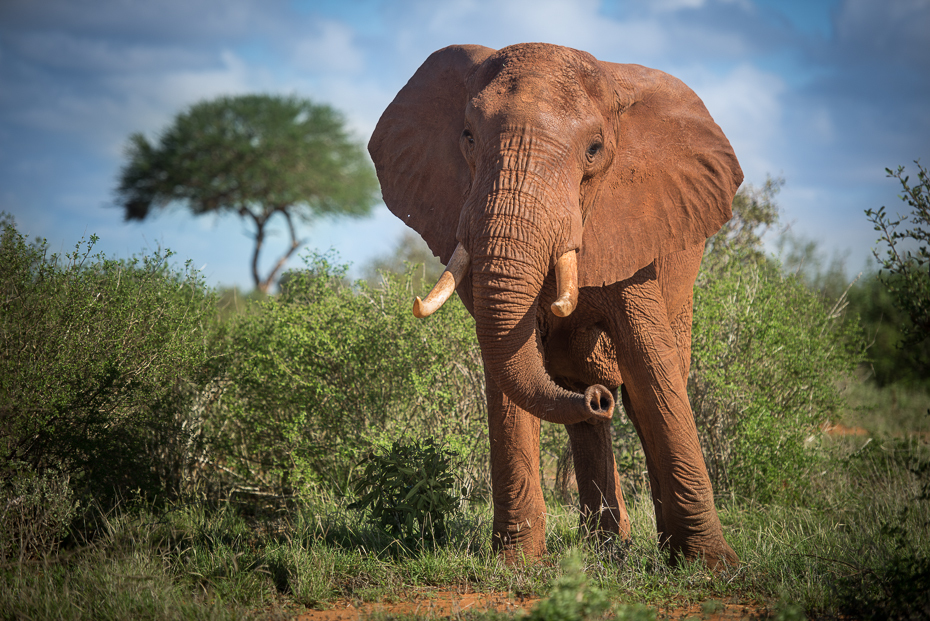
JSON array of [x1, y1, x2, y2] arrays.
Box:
[[413, 244, 578, 319]]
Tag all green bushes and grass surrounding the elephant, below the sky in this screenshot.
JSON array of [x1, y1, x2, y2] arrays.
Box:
[[0, 162, 930, 619]]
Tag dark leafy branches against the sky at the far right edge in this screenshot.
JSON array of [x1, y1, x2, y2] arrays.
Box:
[[865, 162, 930, 345]]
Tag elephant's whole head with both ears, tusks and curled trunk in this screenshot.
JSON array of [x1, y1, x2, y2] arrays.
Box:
[[369, 43, 742, 424]]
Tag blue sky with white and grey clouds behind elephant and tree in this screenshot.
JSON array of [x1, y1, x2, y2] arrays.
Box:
[[0, 0, 930, 289]]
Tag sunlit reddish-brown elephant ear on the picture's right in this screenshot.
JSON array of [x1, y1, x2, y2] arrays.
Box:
[[578, 62, 743, 286]]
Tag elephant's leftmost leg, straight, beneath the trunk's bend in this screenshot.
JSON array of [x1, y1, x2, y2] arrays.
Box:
[[485, 373, 546, 564]]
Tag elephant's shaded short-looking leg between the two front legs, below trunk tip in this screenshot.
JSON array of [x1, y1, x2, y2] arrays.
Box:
[[565, 422, 630, 541]]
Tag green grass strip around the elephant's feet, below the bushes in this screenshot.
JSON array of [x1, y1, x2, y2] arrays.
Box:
[[0, 452, 930, 619]]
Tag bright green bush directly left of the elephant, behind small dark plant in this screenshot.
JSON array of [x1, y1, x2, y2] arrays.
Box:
[[212, 257, 488, 495]]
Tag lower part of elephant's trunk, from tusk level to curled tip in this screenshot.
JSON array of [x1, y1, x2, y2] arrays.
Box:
[[471, 228, 614, 425]]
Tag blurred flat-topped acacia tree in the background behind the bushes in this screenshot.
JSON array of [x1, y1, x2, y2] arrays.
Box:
[[117, 95, 378, 292]]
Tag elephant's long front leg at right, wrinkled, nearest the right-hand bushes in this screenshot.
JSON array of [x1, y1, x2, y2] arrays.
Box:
[[612, 268, 738, 568]]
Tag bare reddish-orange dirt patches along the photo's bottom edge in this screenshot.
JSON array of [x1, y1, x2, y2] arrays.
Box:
[[293, 589, 766, 621]]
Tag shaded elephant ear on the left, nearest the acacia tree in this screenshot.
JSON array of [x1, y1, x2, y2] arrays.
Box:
[[368, 45, 494, 264]]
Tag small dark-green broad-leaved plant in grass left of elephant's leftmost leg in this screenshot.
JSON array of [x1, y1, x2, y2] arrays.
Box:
[[350, 440, 459, 547]]
